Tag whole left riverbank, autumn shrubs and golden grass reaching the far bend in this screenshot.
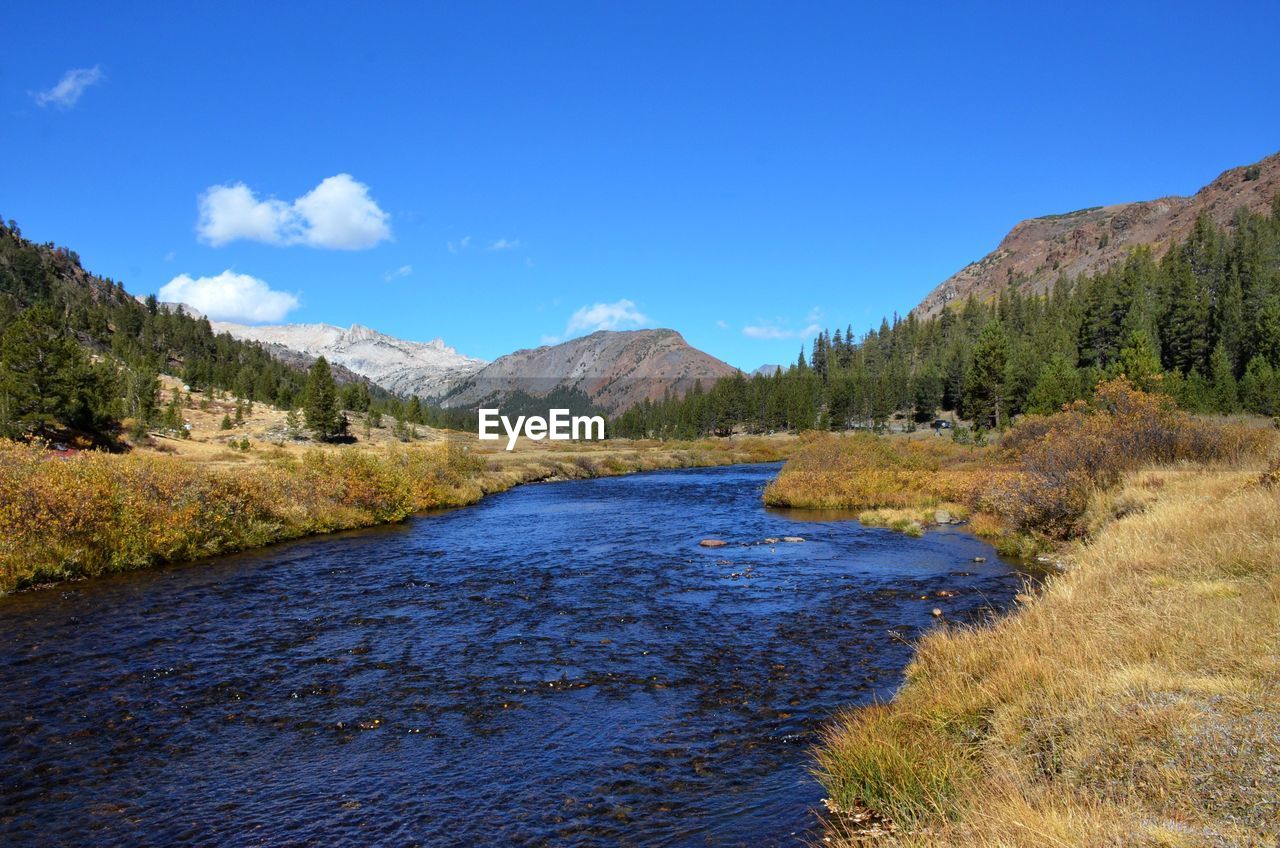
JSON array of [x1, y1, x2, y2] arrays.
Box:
[[0, 434, 791, 592]]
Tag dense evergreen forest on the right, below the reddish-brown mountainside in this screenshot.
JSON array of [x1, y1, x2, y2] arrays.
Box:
[[611, 197, 1280, 438]]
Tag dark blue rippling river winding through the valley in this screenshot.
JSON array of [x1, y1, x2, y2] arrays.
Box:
[[0, 465, 1023, 847]]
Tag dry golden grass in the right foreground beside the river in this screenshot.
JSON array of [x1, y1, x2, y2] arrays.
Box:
[[818, 462, 1280, 845]]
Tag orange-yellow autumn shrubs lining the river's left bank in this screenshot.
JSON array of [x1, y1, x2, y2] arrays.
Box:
[[0, 441, 481, 591]]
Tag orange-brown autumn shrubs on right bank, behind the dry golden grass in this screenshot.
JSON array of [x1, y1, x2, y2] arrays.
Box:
[[764, 378, 1274, 555]]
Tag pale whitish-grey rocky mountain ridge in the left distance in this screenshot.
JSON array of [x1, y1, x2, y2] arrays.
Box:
[[211, 322, 485, 397]]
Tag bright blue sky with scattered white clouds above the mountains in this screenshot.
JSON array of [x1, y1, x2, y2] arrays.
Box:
[[0, 1, 1280, 369]]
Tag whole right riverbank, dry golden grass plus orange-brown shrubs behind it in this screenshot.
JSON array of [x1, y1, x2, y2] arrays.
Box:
[[768, 386, 1280, 845]]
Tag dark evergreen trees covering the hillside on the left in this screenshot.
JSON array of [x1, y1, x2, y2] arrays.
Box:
[[0, 220, 399, 442]]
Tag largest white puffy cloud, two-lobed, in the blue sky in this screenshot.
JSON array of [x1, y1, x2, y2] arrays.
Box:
[[196, 174, 392, 250]]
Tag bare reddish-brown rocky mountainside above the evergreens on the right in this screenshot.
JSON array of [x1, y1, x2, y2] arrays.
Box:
[[911, 154, 1280, 318]]
